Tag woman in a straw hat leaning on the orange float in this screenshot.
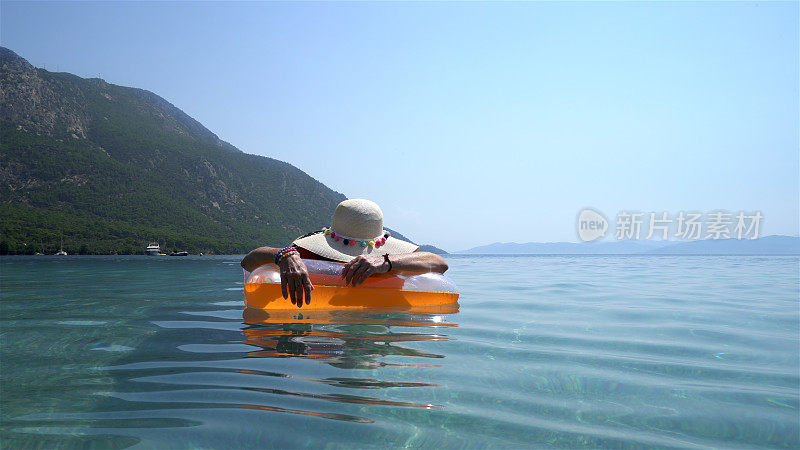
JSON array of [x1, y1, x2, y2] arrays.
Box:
[[242, 199, 447, 307]]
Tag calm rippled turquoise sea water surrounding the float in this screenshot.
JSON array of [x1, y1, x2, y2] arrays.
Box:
[[0, 256, 800, 448]]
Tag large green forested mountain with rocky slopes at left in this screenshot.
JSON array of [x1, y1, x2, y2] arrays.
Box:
[[0, 47, 345, 253]]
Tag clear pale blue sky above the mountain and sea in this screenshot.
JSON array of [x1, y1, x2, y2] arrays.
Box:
[[0, 1, 800, 250]]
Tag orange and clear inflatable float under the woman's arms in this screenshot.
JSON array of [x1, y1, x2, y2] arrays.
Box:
[[244, 259, 458, 310]]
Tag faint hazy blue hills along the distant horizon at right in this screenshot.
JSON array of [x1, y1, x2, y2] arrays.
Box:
[[456, 236, 800, 255]]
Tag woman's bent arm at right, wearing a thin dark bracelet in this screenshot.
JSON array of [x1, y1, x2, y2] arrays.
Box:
[[342, 252, 448, 286]]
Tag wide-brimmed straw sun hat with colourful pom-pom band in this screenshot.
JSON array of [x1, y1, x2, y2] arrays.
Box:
[[294, 199, 419, 262]]
